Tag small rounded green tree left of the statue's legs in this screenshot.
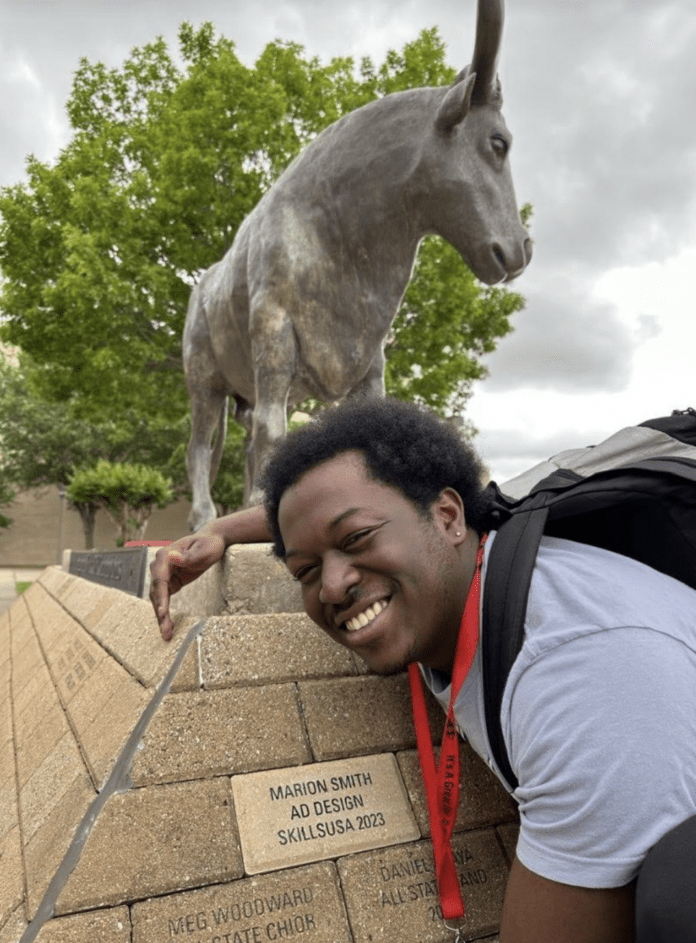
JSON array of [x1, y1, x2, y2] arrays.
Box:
[[66, 459, 173, 547]]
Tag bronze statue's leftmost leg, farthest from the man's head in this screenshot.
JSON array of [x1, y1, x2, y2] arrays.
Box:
[[186, 380, 227, 531]]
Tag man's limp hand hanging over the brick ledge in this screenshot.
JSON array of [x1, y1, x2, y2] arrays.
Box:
[[150, 527, 227, 642]]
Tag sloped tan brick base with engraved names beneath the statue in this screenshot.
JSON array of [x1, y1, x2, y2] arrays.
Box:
[[0, 544, 517, 943]]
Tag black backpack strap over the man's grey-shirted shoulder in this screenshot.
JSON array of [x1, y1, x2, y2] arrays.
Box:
[[481, 499, 548, 789]]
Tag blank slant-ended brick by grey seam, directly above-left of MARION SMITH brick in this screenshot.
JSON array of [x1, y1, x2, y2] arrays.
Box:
[[131, 684, 312, 785]]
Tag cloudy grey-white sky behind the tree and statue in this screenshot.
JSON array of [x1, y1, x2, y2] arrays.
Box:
[[0, 0, 696, 481]]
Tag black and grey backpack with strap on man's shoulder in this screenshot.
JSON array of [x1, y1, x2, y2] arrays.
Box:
[[481, 409, 696, 789]]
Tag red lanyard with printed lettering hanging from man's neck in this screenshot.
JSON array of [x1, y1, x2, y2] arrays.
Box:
[[408, 534, 486, 920]]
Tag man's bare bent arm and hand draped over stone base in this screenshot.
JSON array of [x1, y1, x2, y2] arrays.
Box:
[[150, 504, 271, 641]]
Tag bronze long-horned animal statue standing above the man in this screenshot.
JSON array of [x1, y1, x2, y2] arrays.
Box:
[[183, 0, 532, 530]]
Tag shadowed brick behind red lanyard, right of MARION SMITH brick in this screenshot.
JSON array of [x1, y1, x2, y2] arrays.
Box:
[[397, 743, 517, 837]]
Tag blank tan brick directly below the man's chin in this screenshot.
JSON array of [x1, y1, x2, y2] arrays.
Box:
[[299, 675, 415, 760]]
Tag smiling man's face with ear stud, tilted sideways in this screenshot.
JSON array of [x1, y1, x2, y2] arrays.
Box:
[[278, 452, 470, 674]]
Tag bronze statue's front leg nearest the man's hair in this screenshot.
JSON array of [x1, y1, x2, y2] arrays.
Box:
[[244, 303, 298, 505]]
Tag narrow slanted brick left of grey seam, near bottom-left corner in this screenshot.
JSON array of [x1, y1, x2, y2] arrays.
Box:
[[24, 772, 96, 919]]
